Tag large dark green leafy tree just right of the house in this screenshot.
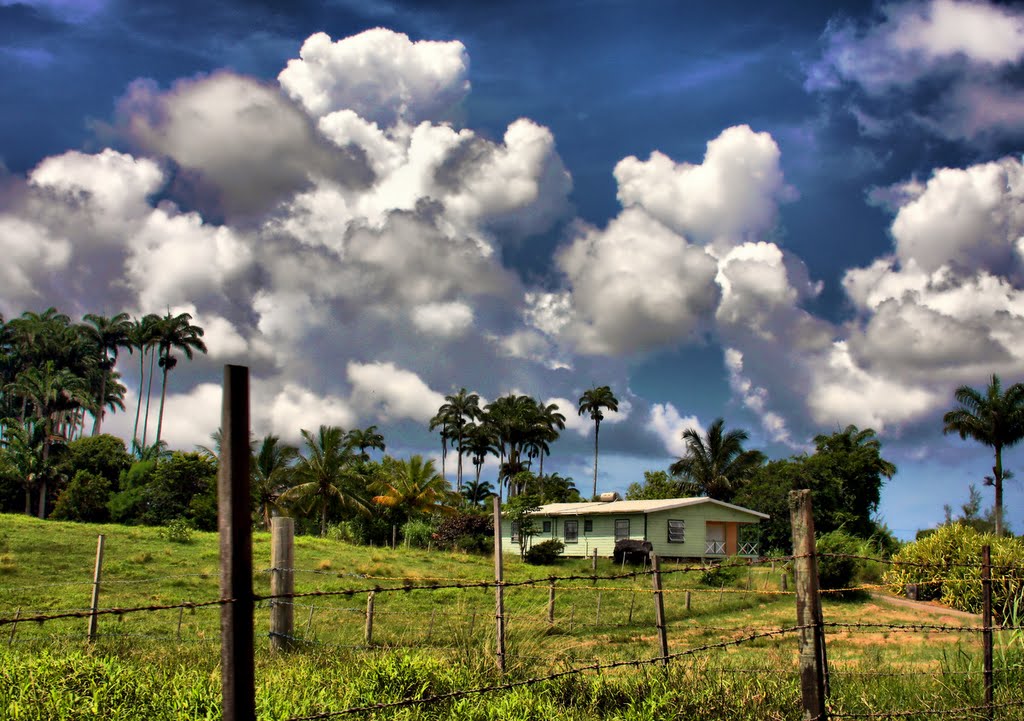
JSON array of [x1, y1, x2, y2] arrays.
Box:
[[732, 426, 896, 553]]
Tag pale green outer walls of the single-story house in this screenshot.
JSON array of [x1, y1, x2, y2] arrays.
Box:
[[502, 503, 760, 558]]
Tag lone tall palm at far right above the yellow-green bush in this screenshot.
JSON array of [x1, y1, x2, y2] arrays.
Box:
[[942, 374, 1024, 536]]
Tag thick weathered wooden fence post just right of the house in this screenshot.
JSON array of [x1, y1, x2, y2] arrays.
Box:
[[790, 491, 828, 721]]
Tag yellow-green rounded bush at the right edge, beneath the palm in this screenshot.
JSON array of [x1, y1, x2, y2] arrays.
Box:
[[885, 523, 1024, 618]]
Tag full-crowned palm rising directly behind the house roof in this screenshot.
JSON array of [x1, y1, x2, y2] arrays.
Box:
[[669, 418, 765, 502]]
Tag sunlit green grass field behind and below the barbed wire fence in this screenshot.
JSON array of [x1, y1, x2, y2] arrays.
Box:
[[0, 515, 1024, 719]]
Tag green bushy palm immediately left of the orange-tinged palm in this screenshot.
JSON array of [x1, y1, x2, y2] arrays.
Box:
[[279, 426, 367, 536]]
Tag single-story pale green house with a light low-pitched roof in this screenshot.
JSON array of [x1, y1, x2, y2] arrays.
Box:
[[502, 498, 768, 558]]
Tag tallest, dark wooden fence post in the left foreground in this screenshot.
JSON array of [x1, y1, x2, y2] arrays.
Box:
[[217, 366, 256, 721]]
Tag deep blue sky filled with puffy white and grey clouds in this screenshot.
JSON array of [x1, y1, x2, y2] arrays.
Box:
[[0, 0, 1024, 538]]
